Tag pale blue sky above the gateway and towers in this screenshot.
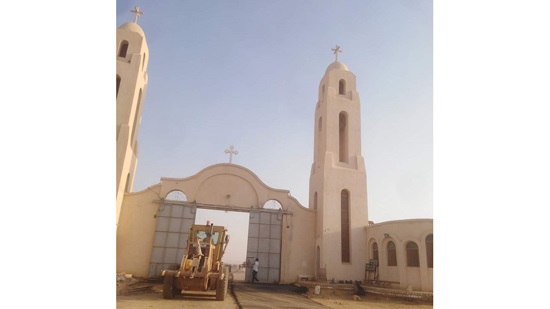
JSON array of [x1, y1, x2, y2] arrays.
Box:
[[117, 0, 433, 222]]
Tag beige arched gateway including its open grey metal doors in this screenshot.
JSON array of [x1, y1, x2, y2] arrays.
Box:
[[117, 164, 315, 283]]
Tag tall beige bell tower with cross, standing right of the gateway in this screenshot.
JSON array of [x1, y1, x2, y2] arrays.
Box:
[[309, 46, 368, 280]]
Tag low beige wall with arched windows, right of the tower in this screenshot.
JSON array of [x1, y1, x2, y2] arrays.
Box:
[[365, 219, 433, 291]]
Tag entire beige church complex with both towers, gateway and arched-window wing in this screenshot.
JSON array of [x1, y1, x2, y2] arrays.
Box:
[[116, 12, 433, 291]]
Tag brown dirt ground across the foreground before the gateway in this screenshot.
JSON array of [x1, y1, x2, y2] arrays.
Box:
[[116, 273, 433, 309]]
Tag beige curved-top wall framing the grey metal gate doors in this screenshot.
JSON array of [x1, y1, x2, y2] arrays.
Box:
[[117, 164, 315, 283]]
